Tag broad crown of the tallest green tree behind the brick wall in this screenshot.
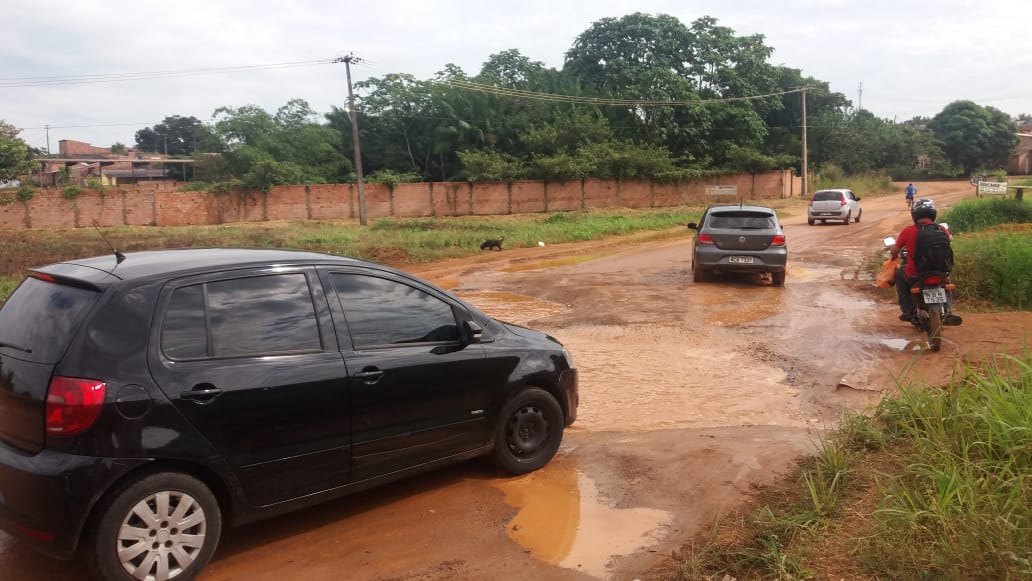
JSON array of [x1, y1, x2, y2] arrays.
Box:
[[563, 12, 779, 162]]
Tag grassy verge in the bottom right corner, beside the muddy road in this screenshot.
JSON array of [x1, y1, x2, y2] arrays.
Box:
[[655, 353, 1032, 580]]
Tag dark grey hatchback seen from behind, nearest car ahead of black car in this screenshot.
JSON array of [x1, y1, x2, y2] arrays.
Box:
[[688, 205, 788, 287]]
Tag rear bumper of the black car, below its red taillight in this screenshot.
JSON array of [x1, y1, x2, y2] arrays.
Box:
[[0, 444, 148, 559]]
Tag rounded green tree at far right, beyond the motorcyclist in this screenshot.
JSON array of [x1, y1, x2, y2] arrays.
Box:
[[929, 101, 1018, 173]]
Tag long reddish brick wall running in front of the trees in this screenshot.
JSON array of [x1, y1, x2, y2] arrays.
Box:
[[0, 170, 801, 229]]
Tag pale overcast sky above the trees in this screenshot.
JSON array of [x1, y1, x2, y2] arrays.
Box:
[[0, 0, 1032, 153]]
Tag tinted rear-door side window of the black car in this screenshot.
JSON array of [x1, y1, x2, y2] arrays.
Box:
[[161, 273, 322, 359]]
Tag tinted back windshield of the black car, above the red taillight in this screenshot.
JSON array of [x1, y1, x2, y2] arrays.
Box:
[[0, 278, 100, 363]]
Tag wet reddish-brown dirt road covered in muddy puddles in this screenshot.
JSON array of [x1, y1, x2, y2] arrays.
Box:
[[0, 183, 1032, 581]]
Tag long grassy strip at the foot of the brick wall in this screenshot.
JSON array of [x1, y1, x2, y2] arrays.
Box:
[[0, 206, 701, 301]]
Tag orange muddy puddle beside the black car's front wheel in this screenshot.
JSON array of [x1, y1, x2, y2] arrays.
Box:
[[495, 467, 673, 578]]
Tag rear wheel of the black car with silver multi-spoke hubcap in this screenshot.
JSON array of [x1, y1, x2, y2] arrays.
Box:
[[86, 472, 222, 581]]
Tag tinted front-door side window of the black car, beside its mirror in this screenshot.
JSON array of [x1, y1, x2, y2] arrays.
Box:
[[332, 272, 459, 349]]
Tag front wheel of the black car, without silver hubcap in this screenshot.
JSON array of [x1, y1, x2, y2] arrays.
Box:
[[494, 387, 563, 476]]
